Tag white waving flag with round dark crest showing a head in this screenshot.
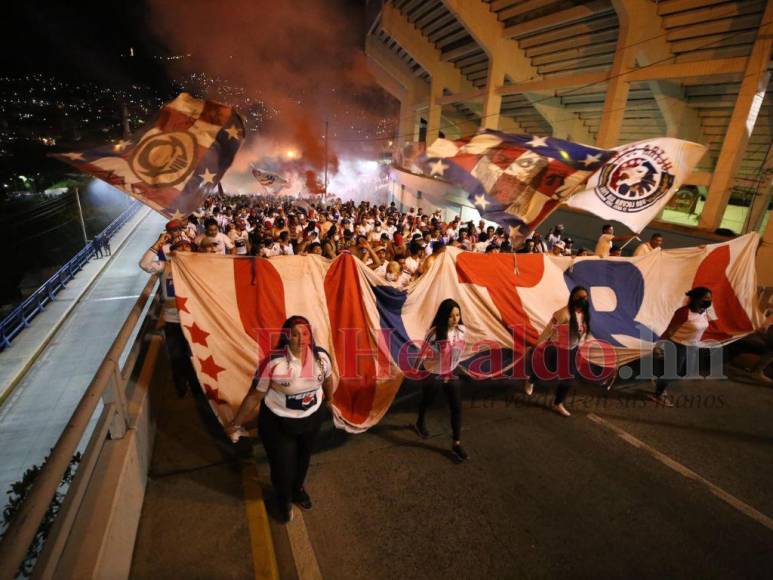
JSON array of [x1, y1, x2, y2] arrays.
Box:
[[567, 137, 706, 233]]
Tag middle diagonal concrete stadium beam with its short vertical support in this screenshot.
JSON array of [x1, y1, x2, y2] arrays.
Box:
[[433, 0, 593, 143]]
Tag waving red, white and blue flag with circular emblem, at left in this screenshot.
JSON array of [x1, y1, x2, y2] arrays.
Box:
[[52, 93, 244, 218]]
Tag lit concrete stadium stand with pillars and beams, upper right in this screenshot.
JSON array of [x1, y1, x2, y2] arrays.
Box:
[[365, 0, 773, 285]]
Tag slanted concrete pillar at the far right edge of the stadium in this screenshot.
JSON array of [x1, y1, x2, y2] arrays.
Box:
[[698, 0, 773, 231]]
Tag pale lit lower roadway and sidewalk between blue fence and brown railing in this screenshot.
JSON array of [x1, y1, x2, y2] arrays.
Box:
[[0, 210, 164, 504]]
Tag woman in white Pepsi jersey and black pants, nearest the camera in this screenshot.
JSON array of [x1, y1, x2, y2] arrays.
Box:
[[227, 316, 333, 522]]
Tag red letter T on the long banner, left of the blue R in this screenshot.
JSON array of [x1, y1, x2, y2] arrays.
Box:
[[456, 252, 545, 344]]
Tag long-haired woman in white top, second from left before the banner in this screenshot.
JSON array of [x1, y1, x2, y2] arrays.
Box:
[[414, 298, 467, 462]]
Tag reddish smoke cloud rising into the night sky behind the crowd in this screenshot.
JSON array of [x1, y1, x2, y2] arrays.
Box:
[[148, 0, 398, 195]]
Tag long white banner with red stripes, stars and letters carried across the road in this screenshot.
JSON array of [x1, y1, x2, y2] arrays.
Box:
[[172, 234, 763, 432]]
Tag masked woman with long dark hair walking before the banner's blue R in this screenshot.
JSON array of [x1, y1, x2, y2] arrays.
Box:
[[525, 286, 590, 417]]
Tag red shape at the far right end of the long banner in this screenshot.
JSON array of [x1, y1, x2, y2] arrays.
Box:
[[692, 246, 754, 340]]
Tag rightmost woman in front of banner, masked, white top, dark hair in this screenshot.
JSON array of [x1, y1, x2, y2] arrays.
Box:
[[650, 286, 716, 407]]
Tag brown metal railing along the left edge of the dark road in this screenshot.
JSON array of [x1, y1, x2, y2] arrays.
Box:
[[0, 276, 160, 580]]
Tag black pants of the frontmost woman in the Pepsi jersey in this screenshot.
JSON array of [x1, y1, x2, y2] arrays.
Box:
[[258, 403, 322, 506]]
